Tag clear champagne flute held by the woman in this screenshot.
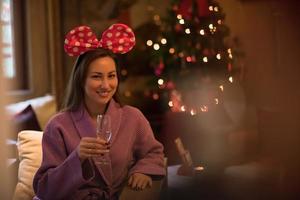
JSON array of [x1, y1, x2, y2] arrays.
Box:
[[96, 114, 112, 164]]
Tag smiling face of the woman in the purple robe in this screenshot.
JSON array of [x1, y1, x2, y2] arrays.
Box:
[[84, 56, 118, 112]]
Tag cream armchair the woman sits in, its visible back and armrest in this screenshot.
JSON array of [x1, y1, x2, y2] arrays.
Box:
[[13, 130, 166, 200]]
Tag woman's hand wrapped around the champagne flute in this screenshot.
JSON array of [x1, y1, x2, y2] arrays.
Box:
[[76, 137, 109, 162]]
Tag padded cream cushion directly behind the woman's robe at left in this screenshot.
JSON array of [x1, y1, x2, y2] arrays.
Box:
[[13, 130, 43, 200]]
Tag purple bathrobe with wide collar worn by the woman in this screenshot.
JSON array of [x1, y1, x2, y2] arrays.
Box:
[[33, 100, 165, 200]]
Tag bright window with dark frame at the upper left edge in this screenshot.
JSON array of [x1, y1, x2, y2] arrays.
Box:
[[1, 0, 28, 90]]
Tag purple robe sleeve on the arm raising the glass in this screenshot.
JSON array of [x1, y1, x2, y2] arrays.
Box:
[[33, 120, 94, 200]]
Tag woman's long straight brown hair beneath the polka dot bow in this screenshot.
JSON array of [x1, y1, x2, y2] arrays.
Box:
[[62, 48, 121, 111]]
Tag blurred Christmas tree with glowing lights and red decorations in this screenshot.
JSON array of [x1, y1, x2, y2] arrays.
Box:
[[123, 0, 240, 115]]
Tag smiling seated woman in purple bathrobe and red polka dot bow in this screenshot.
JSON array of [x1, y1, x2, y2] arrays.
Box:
[[33, 24, 165, 200]]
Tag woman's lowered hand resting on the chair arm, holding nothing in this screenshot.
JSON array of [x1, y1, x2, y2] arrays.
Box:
[[128, 173, 152, 190]]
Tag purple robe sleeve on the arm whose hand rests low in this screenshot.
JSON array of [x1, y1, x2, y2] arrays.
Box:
[[129, 113, 166, 176]]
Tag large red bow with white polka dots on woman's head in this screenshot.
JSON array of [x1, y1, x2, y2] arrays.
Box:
[[64, 24, 135, 56]]
